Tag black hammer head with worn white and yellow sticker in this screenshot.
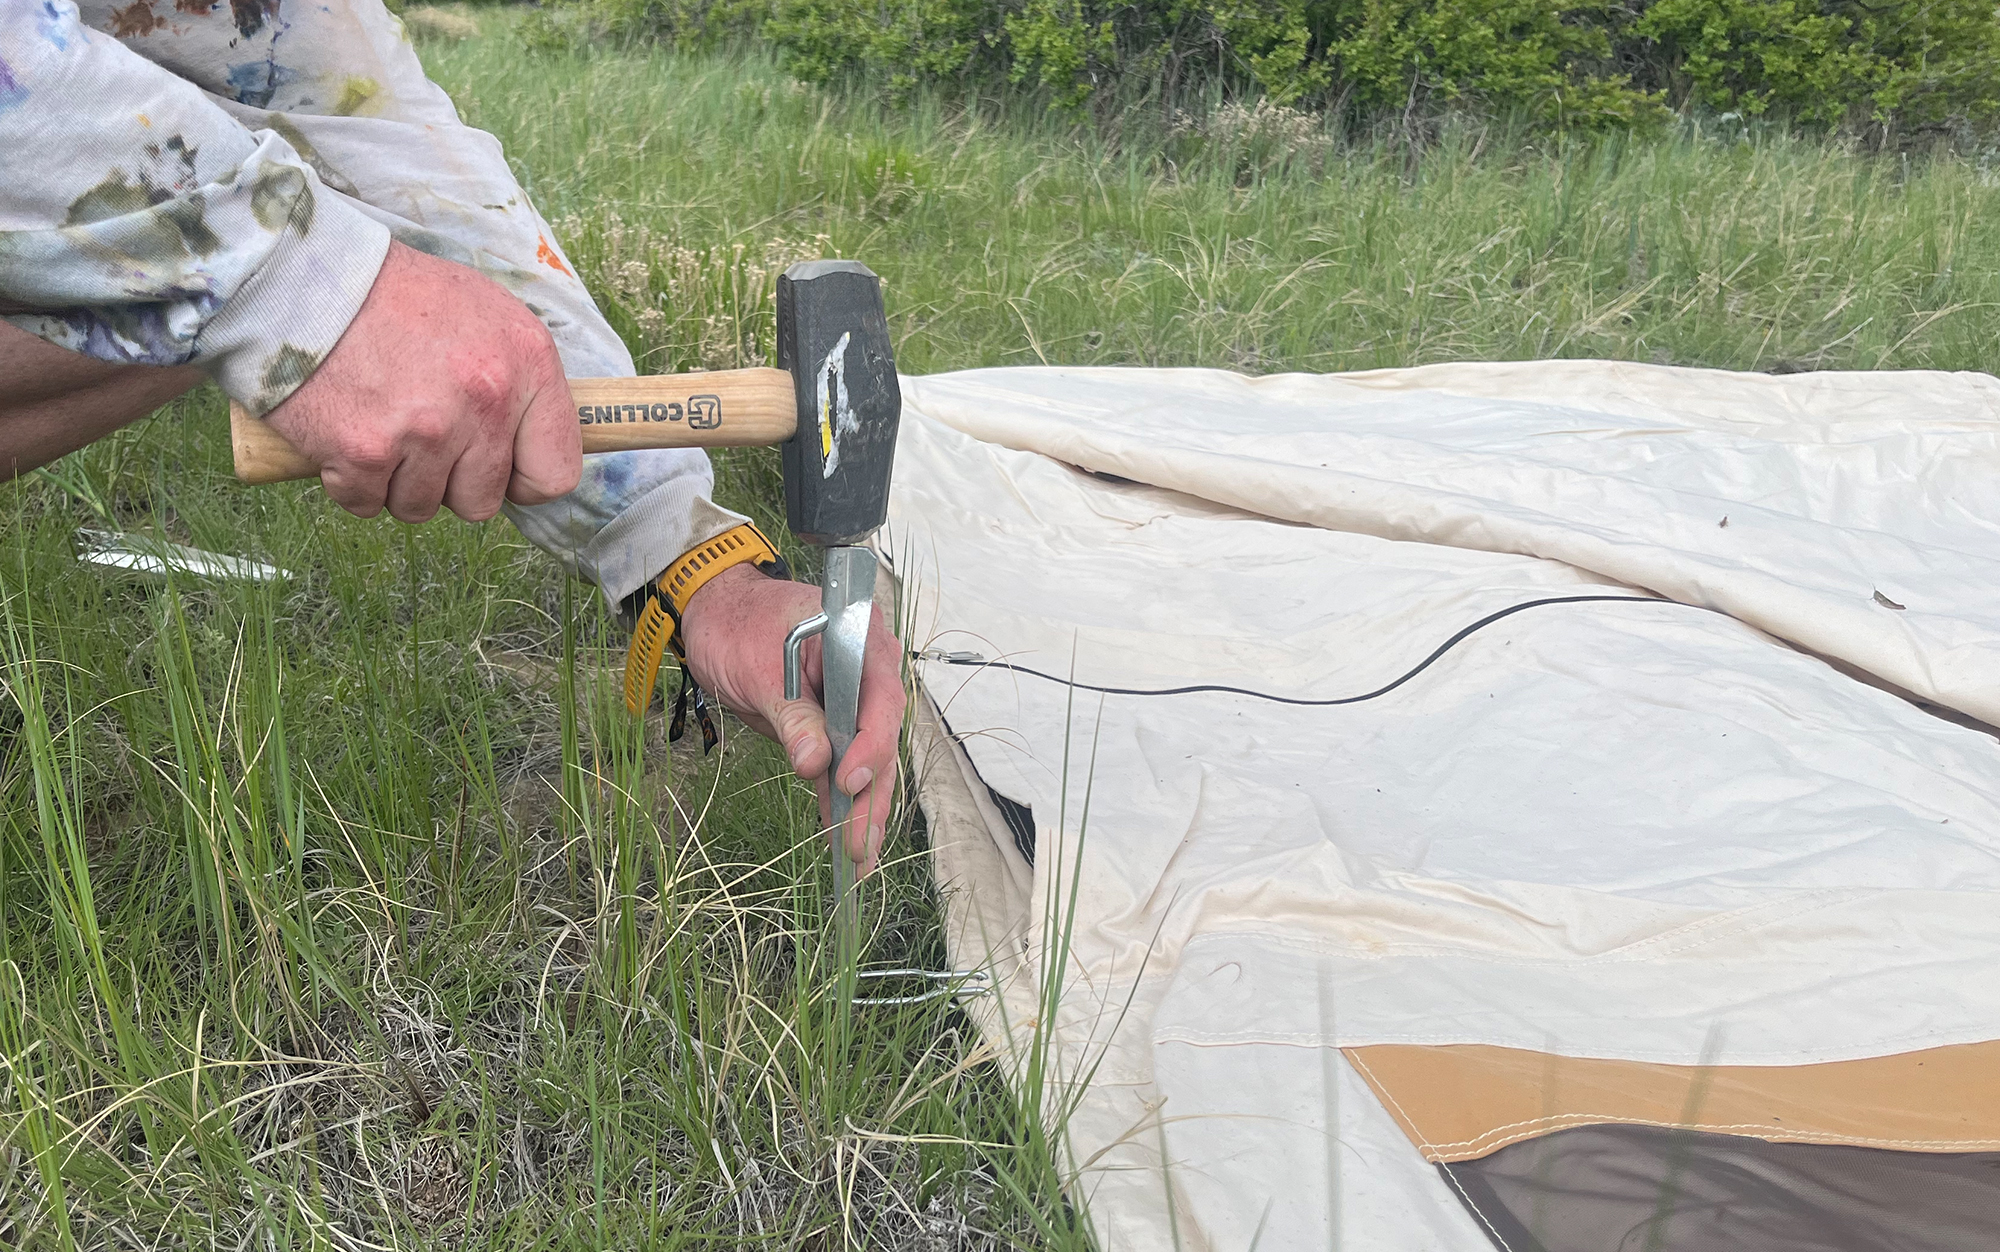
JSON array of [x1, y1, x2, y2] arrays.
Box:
[[778, 260, 902, 546]]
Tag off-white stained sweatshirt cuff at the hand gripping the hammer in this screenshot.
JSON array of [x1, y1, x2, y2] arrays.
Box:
[[196, 166, 390, 418]]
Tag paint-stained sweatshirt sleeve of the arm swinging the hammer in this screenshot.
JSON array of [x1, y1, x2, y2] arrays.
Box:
[[0, 0, 390, 414]]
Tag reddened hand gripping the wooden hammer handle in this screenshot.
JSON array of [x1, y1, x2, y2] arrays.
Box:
[[268, 244, 582, 522]]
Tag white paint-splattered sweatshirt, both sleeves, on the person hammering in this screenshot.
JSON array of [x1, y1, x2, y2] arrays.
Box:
[[0, 0, 742, 602]]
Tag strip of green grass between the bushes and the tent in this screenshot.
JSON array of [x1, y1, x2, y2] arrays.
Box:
[[430, 17, 2000, 372]]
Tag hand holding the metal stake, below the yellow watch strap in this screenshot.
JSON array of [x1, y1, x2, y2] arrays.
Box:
[[680, 566, 904, 874]]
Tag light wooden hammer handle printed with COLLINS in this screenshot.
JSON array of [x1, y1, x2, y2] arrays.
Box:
[[230, 368, 798, 484]]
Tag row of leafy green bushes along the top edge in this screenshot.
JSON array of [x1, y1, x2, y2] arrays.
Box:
[[528, 0, 2000, 128]]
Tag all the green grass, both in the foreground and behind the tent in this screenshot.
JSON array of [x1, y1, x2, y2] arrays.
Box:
[[11, 14, 2000, 1248]]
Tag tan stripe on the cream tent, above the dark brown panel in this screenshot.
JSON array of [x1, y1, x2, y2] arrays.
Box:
[[1344, 1040, 2000, 1162]]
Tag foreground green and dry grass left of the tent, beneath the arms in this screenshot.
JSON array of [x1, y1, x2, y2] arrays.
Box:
[[0, 396, 1062, 1248]]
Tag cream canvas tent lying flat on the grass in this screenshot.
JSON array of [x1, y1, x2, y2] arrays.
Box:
[[882, 362, 2000, 1252]]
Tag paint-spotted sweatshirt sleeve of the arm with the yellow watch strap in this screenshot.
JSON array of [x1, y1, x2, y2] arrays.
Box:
[[160, 0, 744, 606]]
